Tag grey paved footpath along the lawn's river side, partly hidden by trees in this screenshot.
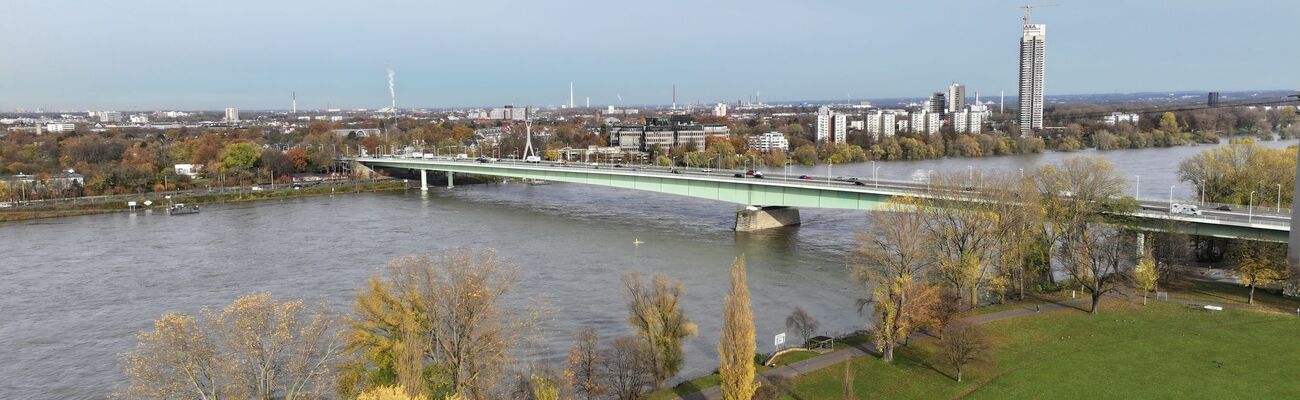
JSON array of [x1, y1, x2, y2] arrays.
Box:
[[681, 297, 1089, 400]]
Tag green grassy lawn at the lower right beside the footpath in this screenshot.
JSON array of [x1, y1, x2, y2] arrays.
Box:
[[787, 301, 1300, 399]]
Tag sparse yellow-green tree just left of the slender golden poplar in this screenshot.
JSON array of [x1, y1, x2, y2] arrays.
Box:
[[623, 273, 696, 386]]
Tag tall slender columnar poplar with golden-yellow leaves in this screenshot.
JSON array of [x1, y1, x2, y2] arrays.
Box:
[[718, 257, 759, 400]]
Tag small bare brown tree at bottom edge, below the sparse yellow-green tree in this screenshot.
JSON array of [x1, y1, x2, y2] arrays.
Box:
[[599, 336, 657, 400]]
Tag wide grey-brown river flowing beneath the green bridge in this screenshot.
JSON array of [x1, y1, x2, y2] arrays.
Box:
[[0, 140, 1295, 399]]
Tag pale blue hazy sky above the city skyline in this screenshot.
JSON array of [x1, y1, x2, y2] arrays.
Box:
[[0, 0, 1300, 110]]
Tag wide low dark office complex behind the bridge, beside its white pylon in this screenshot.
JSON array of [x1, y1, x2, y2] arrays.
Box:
[[610, 116, 731, 152]]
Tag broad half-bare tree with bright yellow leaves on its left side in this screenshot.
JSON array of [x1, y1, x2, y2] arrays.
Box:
[[339, 249, 536, 399]]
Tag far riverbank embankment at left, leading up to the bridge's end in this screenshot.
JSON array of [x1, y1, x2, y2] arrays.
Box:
[[0, 179, 407, 223]]
